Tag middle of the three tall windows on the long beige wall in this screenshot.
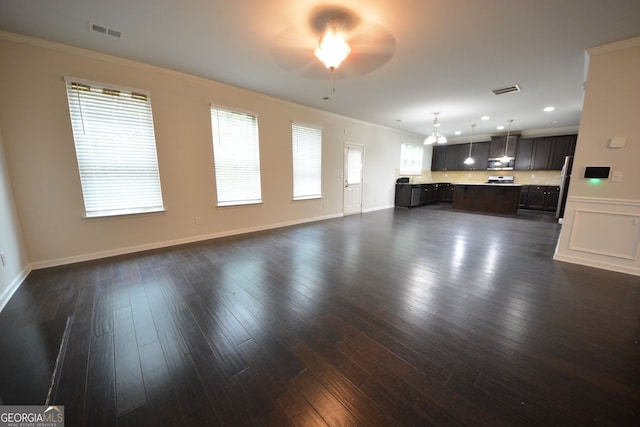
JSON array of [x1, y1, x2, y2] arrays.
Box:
[[211, 106, 262, 206]]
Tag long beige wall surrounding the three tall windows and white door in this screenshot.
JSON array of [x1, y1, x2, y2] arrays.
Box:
[[0, 33, 422, 268]]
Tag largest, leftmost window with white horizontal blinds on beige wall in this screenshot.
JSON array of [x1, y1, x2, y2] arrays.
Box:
[[66, 79, 163, 217]]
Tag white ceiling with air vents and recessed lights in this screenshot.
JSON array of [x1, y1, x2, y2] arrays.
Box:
[[0, 0, 640, 142]]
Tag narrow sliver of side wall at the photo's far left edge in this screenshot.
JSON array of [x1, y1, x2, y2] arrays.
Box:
[[0, 127, 30, 310]]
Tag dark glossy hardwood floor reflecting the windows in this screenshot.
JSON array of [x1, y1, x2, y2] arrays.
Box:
[[0, 204, 640, 426]]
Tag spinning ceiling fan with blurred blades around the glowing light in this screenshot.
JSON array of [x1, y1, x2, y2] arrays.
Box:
[[271, 6, 396, 80]]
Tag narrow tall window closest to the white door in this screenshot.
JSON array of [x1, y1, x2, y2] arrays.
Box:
[[291, 123, 322, 200]]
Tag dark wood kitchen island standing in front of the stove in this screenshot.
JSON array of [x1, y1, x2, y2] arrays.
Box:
[[453, 183, 522, 215]]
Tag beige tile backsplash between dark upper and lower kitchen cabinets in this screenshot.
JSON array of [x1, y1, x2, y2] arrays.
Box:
[[398, 170, 560, 185]]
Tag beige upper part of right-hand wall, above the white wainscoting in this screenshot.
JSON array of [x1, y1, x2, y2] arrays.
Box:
[[570, 39, 640, 201]]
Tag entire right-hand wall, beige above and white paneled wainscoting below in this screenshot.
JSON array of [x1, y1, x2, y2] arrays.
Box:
[[556, 38, 640, 275]]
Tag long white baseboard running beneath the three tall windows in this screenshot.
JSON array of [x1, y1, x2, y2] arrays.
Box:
[[31, 213, 344, 270]]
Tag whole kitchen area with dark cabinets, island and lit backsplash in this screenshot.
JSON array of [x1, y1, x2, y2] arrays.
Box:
[[395, 134, 577, 221]]
